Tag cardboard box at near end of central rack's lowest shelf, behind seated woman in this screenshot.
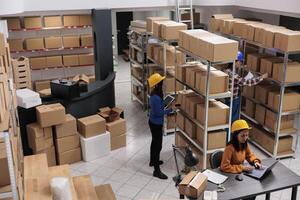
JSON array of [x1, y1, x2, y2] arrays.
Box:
[[196, 127, 227, 150]]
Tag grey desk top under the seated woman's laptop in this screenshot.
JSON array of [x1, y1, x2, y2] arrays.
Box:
[[206, 159, 300, 200]]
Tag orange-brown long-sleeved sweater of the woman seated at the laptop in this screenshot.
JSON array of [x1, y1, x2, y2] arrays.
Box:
[[220, 144, 260, 174]]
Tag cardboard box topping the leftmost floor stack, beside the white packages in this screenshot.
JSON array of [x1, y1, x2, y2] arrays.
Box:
[[36, 103, 66, 128]]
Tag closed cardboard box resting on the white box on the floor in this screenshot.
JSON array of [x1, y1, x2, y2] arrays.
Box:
[[77, 115, 106, 138]]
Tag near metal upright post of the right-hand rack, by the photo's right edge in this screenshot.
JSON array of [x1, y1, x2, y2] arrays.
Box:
[[273, 52, 289, 158]]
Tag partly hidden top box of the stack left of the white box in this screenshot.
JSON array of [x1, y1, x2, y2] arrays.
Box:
[[54, 114, 77, 138]]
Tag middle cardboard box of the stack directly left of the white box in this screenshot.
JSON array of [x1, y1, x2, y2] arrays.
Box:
[[55, 134, 80, 153]]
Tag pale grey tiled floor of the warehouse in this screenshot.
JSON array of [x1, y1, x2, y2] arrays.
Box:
[[71, 59, 300, 200]]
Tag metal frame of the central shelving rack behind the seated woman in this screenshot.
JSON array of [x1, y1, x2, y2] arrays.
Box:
[[175, 47, 235, 169]]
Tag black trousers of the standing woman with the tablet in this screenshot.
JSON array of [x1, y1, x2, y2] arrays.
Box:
[[149, 120, 163, 170]]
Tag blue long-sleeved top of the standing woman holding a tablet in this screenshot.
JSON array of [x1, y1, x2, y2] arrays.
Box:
[[149, 95, 172, 125]]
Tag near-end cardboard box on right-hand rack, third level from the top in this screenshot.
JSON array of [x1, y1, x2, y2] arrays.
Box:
[[268, 91, 300, 112]]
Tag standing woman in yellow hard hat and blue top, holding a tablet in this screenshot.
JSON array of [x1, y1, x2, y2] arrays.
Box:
[[148, 73, 172, 179]]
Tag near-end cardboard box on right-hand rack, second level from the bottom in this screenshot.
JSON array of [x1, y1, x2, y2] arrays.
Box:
[[265, 110, 295, 131]]
